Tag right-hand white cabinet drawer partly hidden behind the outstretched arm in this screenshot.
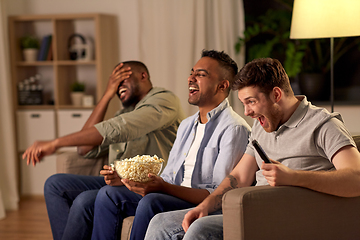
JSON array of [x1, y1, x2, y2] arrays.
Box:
[[57, 110, 92, 151]]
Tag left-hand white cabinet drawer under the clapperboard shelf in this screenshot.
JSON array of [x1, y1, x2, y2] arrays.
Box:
[[16, 110, 55, 152]]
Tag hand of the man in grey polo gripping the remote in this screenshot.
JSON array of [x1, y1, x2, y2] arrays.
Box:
[[261, 159, 296, 186]]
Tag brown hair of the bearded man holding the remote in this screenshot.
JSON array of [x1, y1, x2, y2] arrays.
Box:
[[231, 58, 294, 96]]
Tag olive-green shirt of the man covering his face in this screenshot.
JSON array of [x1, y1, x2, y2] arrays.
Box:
[[85, 88, 184, 166]]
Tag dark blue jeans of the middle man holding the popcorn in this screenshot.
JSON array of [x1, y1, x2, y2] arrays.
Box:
[[92, 186, 195, 240]]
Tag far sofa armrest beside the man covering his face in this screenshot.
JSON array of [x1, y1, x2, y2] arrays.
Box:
[[56, 152, 108, 176]]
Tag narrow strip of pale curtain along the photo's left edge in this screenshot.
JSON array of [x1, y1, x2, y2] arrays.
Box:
[[0, 0, 19, 219]]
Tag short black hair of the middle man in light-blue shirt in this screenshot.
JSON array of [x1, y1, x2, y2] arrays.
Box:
[[201, 49, 238, 92]]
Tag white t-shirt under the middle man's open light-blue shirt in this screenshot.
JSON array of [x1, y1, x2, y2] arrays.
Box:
[[181, 122, 206, 187]]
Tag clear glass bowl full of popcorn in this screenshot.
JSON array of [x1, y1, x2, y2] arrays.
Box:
[[112, 155, 164, 182]]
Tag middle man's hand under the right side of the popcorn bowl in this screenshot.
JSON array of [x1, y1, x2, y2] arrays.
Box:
[[121, 173, 164, 197]]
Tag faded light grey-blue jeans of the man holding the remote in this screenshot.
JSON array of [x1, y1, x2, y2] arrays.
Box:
[[145, 209, 223, 240]]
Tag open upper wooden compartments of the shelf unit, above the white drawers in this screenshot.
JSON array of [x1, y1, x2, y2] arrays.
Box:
[[9, 13, 118, 113]]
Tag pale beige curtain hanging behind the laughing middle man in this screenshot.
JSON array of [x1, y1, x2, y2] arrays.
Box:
[[137, 0, 250, 121]]
